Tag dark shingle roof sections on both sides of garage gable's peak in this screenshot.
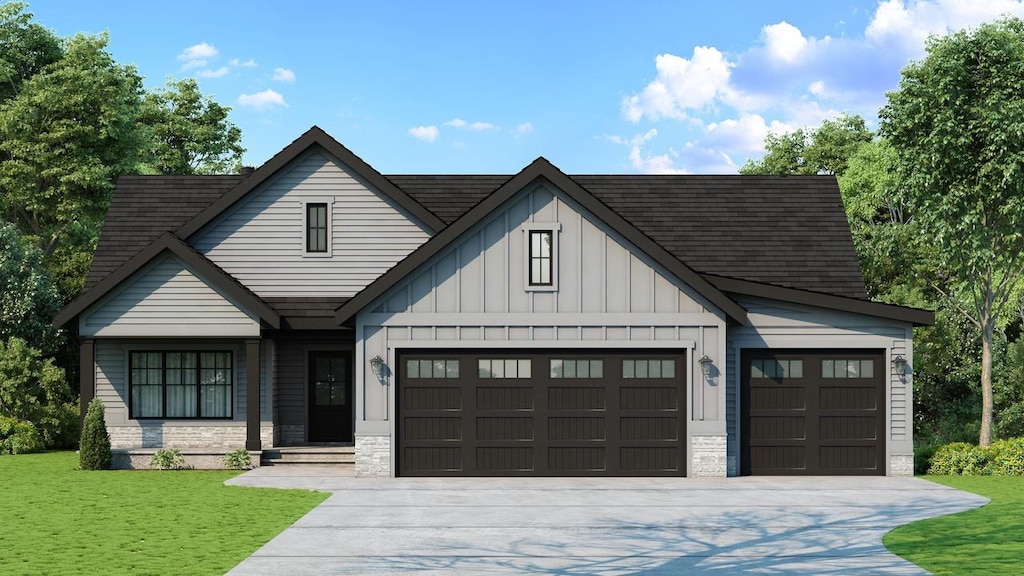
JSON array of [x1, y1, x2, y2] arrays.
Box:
[[388, 175, 867, 299]]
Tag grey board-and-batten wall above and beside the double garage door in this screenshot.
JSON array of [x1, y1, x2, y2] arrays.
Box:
[[355, 182, 726, 436]]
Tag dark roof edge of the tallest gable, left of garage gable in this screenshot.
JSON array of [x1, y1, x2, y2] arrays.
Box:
[[177, 126, 444, 240]]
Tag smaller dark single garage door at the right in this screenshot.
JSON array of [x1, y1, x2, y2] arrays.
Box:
[[740, 351, 887, 476]]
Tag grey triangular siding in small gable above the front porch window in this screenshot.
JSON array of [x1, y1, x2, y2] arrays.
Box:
[[79, 253, 260, 337]]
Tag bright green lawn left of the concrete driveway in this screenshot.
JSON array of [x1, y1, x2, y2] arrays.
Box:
[[0, 452, 328, 575]]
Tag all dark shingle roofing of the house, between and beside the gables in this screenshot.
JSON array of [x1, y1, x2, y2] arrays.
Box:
[[86, 170, 866, 303]]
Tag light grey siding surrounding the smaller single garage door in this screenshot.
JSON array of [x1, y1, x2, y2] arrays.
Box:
[[726, 296, 913, 475]]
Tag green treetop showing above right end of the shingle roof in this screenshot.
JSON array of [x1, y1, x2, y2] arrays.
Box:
[[739, 114, 873, 175]]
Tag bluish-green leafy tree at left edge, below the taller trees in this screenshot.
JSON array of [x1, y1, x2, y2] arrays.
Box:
[[0, 221, 60, 354]]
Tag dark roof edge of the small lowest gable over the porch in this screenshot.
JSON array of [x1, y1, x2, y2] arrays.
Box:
[[53, 228, 281, 328]]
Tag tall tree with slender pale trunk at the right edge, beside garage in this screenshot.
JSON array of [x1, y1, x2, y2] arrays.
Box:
[[879, 18, 1024, 446]]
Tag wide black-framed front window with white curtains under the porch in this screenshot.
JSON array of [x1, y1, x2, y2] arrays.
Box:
[[128, 352, 233, 418]]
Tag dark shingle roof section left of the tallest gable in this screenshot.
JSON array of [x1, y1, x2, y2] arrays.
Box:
[[85, 175, 245, 290]]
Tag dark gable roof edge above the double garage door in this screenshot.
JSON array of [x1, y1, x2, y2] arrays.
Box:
[[335, 158, 746, 324]]
